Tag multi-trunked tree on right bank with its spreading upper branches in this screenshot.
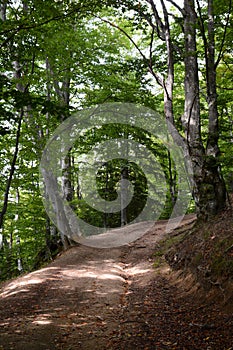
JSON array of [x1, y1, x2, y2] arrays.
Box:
[[104, 0, 231, 219]]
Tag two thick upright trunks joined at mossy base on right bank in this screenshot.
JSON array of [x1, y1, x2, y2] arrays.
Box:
[[183, 0, 226, 220]]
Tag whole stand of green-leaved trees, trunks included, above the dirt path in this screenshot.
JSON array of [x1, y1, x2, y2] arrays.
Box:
[[0, 0, 233, 279]]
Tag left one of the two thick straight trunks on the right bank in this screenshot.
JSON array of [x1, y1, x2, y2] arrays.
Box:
[[182, 0, 205, 214]]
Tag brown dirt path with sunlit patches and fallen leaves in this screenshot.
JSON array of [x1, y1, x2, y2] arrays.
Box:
[[0, 215, 233, 350]]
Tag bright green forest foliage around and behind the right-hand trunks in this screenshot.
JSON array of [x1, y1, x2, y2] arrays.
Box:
[[0, 0, 233, 279]]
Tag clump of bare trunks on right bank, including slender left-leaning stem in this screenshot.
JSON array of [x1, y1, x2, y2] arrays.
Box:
[[148, 0, 226, 219]]
